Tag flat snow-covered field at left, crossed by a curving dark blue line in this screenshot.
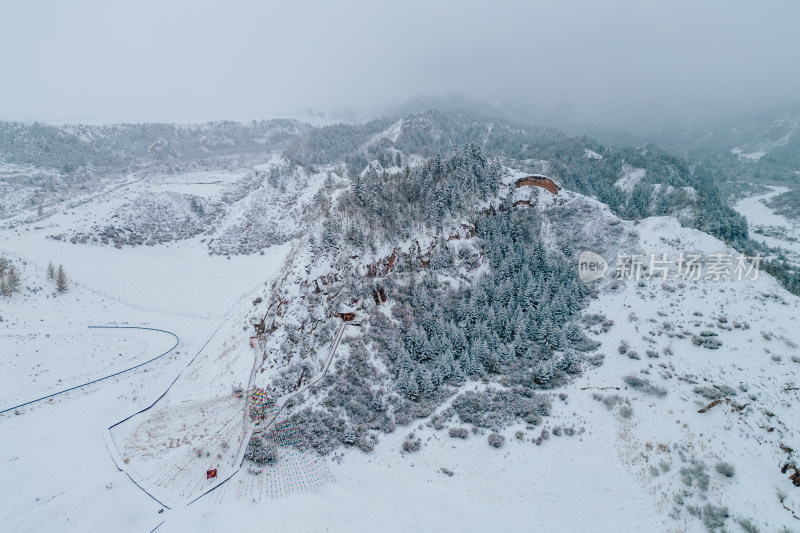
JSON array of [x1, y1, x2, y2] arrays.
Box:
[[0, 160, 290, 531]]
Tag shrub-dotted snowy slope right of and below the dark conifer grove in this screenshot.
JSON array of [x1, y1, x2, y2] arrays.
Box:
[[150, 208, 800, 531]]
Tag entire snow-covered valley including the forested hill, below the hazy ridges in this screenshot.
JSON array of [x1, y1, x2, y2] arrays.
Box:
[[0, 114, 800, 533]]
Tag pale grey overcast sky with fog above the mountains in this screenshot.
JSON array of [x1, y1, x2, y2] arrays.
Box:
[[0, 0, 800, 130]]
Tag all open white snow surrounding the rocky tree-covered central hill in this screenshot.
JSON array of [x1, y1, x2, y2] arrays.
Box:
[[0, 159, 800, 532]]
